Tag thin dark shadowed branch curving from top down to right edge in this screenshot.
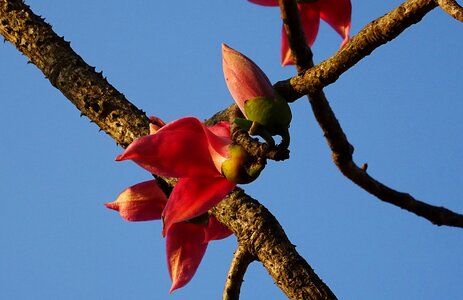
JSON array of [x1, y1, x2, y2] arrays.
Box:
[[280, 0, 463, 227]]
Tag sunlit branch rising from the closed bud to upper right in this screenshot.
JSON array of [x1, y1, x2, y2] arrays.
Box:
[[274, 0, 437, 102]]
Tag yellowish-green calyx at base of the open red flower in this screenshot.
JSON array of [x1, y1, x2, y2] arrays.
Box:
[[222, 144, 265, 184]]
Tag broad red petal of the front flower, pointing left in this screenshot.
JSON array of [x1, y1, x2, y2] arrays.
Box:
[[116, 117, 220, 177]]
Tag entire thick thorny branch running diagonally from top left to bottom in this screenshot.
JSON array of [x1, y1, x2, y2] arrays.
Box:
[[0, 0, 335, 299]]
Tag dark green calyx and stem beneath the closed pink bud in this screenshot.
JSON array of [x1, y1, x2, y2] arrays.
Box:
[[235, 95, 292, 147]]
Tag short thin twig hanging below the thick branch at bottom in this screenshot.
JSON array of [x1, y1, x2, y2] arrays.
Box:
[[222, 245, 255, 300]]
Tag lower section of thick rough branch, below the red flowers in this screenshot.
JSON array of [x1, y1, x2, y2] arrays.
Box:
[[212, 189, 336, 299]]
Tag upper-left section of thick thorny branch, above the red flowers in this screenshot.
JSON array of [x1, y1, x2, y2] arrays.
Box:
[[0, 0, 149, 147]]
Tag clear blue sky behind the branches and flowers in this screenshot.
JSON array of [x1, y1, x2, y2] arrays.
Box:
[[0, 0, 463, 299]]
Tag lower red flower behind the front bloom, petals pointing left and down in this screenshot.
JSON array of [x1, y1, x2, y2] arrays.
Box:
[[105, 180, 232, 292]]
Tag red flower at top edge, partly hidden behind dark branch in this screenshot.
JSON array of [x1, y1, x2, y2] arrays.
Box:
[[248, 0, 352, 66]]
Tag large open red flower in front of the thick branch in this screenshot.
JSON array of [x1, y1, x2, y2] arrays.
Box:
[[116, 117, 236, 235]]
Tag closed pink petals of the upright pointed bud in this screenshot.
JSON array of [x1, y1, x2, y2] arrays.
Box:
[[222, 44, 275, 114]]
